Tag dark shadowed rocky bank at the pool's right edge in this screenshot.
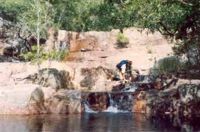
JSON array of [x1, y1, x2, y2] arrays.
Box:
[[146, 83, 200, 126]]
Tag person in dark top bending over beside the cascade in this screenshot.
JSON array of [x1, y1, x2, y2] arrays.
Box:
[[116, 60, 132, 81]]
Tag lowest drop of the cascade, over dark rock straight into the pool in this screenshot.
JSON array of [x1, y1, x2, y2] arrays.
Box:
[[83, 92, 134, 113]]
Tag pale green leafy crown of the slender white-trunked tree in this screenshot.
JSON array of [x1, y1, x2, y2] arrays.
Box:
[[19, 0, 56, 38]]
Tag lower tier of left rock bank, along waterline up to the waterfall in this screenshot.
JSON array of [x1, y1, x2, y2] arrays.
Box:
[[0, 84, 81, 115]]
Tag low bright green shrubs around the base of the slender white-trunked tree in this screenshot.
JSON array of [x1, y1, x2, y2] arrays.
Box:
[[21, 46, 67, 63]]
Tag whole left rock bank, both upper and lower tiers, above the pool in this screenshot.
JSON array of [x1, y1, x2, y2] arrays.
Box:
[[0, 62, 81, 115]]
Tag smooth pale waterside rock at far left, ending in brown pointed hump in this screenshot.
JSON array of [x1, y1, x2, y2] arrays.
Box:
[[0, 84, 50, 114]]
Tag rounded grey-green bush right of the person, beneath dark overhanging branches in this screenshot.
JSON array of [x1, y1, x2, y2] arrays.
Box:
[[150, 56, 187, 76]]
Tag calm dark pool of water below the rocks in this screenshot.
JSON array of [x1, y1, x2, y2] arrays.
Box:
[[0, 113, 193, 132]]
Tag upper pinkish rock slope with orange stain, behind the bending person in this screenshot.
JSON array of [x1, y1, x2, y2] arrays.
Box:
[[58, 28, 172, 73]]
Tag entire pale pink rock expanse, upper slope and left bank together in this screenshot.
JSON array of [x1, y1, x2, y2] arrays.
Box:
[[0, 28, 172, 114]]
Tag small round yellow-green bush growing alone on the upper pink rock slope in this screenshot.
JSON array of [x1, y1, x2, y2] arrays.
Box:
[[117, 33, 129, 48]]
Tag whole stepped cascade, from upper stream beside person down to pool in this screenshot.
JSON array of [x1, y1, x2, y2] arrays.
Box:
[[83, 75, 154, 113]]
